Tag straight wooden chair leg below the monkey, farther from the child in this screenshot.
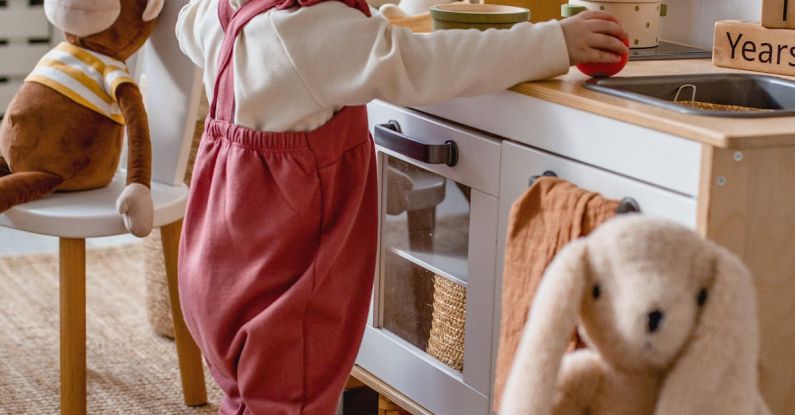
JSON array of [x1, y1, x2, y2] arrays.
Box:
[[60, 238, 86, 415]]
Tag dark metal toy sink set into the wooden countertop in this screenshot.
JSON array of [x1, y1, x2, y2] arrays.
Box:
[[585, 74, 795, 118]]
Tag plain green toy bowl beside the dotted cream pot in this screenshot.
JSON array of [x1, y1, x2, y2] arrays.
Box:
[[431, 3, 530, 30]]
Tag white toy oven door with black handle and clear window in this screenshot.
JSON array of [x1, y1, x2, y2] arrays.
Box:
[[357, 102, 500, 414]]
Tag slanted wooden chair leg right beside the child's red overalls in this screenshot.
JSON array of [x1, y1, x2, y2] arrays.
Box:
[[160, 220, 207, 406]]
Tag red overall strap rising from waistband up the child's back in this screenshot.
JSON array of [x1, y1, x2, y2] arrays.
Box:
[[210, 0, 281, 122]]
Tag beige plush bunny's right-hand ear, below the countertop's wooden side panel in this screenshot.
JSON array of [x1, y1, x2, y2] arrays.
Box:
[[655, 244, 760, 415]]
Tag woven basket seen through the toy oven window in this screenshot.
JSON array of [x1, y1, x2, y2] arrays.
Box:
[[427, 275, 467, 371]]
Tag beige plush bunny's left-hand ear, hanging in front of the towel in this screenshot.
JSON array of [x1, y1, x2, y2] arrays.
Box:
[[500, 239, 588, 415]]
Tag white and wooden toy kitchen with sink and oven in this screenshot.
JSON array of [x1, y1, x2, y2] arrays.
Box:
[[354, 0, 795, 415]]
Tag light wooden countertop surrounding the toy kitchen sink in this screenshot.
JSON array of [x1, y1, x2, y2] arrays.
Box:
[[511, 59, 795, 148]]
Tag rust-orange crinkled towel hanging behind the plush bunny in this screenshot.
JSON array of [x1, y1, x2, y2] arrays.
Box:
[[494, 177, 619, 411]]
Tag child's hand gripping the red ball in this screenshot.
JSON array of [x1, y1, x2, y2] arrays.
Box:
[[560, 11, 629, 65]]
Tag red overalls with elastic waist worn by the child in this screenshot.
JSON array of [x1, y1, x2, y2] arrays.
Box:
[[179, 0, 378, 415]]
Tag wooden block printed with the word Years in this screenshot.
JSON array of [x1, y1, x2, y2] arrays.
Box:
[[712, 20, 795, 75]]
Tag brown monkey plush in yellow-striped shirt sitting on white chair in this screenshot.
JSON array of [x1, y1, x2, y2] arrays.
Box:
[[0, 0, 165, 236]]
